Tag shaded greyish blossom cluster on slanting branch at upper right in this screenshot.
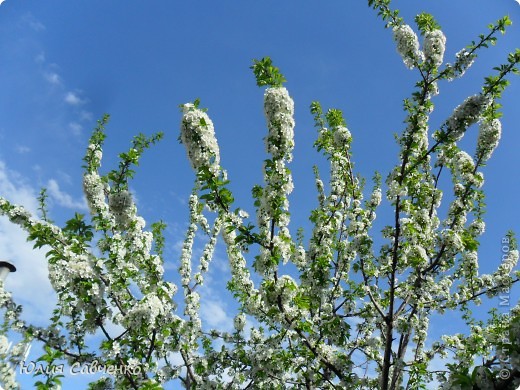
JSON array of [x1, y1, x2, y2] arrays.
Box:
[[446, 94, 492, 141]]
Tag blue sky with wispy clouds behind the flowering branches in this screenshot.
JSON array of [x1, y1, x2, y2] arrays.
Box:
[[0, 0, 520, 388]]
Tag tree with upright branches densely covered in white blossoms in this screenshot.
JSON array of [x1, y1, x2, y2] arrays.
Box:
[[0, 0, 520, 390]]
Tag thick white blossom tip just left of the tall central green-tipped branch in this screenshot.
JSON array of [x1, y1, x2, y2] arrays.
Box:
[[181, 103, 220, 171]]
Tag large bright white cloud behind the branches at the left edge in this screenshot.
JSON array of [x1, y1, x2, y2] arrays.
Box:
[[0, 161, 56, 325]]
